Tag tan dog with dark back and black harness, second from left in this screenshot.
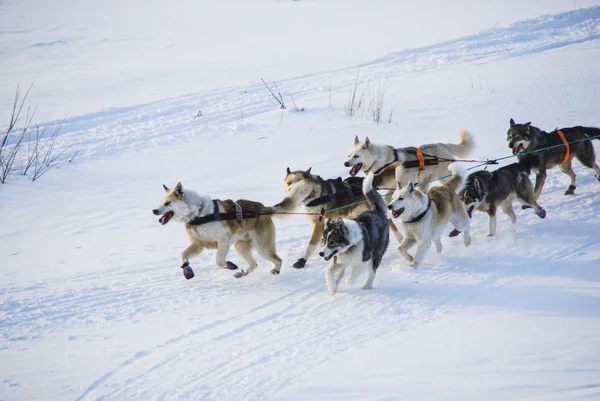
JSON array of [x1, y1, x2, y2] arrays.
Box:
[[273, 165, 402, 269]]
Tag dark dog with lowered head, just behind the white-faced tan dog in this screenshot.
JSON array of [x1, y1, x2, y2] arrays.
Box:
[[458, 163, 546, 237]]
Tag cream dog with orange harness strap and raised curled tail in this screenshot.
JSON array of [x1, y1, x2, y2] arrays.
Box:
[[344, 129, 475, 192]]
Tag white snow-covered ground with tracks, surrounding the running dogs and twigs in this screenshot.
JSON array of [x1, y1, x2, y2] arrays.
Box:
[[0, 0, 600, 400]]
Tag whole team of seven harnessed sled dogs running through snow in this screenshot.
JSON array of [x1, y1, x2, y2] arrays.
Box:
[[152, 119, 600, 294]]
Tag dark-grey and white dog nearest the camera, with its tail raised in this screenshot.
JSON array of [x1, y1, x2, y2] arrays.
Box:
[[319, 173, 389, 295]]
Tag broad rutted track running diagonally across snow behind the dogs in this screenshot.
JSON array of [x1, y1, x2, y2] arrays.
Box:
[[41, 7, 600, 157]]
